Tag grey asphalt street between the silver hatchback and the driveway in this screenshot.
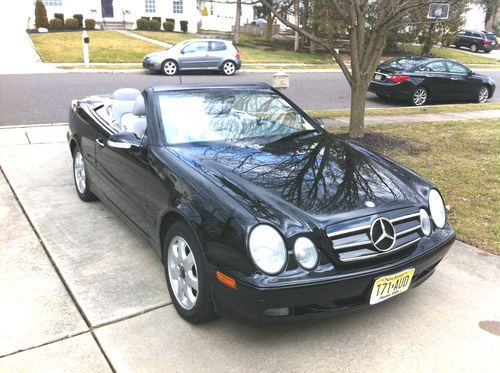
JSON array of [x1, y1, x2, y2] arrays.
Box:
[[0, 71, 500, 126]]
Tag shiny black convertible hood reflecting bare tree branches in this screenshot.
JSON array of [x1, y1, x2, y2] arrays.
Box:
[[171, 133, 426, 228]]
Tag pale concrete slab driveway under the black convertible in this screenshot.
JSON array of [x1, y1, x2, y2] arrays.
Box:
[[0, 125, 500, 372]]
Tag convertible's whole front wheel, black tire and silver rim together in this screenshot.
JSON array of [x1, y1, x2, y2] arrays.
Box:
[[163, 222, 216, 324]]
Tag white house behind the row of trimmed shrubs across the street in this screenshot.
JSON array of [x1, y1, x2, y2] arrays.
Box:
[[22, 0, 256, 32]]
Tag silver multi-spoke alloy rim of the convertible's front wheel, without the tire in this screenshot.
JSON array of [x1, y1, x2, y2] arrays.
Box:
[[167, 236, 198, 310]]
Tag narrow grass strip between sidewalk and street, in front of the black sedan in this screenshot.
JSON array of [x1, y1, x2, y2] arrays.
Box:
[[306, 102, 500, 118]]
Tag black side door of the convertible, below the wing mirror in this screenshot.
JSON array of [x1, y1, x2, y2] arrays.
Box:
[[96, 123, 148, 232]]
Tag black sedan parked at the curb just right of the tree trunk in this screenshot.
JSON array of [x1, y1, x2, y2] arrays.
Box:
[[368, 56, 495, 106]]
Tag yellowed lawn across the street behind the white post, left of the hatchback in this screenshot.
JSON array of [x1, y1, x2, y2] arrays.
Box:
[[30, 31, 161, 62]]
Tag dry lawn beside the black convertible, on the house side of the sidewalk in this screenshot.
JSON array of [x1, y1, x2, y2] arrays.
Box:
[[334, 119, 500, 254]]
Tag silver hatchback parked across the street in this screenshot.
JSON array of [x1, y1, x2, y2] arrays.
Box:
[[142, 39, 241, 75]]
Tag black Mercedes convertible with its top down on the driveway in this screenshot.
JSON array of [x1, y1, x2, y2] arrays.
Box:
[[68, 84, 455, 323]]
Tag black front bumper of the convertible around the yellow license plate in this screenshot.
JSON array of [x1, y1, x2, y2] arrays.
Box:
[[212, 226, 455, 325]]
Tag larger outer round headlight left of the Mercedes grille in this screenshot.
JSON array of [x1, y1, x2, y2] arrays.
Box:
[[248, 224, 287, 275]]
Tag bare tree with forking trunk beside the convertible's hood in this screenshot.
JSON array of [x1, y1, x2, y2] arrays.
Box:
[[261, 0, 455, 138]]
